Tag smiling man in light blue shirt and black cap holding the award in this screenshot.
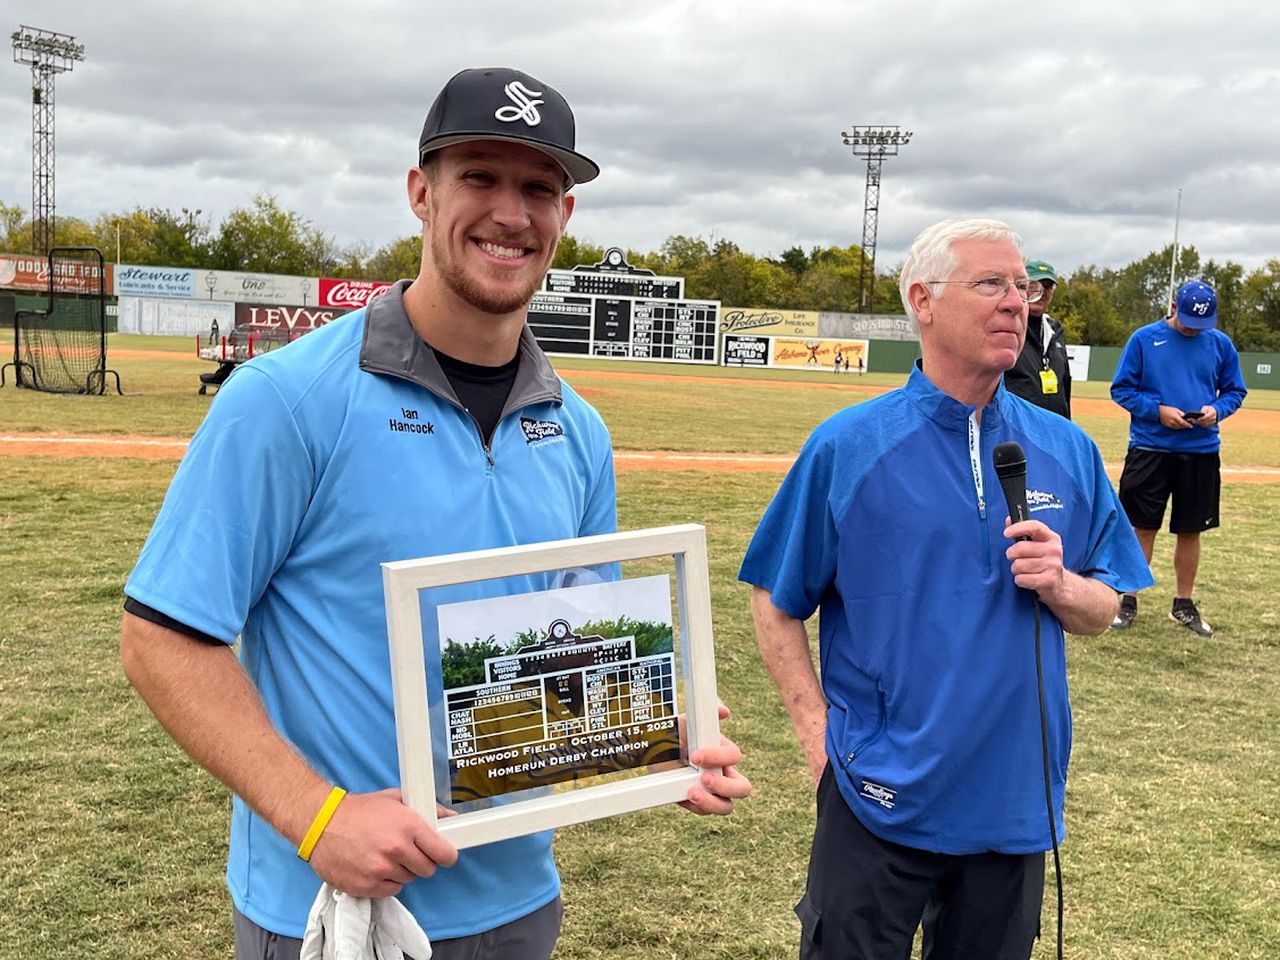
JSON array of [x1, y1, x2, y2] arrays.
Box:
[[120, 68, 750, 960]]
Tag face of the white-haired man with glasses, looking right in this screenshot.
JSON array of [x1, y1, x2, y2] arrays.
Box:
[[910, 239, 1027, 402]]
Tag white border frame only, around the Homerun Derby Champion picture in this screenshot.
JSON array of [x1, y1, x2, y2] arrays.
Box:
[[381, 524, 719, 849]]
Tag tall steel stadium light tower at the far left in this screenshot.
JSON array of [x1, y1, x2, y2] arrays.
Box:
[[13, 26, 84, 256]]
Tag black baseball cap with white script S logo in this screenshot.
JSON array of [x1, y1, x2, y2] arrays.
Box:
[[417, 67, 600, 186]]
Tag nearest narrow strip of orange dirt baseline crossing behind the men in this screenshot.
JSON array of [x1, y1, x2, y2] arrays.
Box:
[[0, 434, 1280, 484]]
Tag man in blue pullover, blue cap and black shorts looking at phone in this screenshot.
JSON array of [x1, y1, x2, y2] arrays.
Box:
[[1111, 280, 1247, 636]]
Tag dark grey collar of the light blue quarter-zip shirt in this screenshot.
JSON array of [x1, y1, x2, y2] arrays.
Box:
[[360, 280, 563, 413]]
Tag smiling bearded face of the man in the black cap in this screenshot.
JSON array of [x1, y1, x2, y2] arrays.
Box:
[[410, 141, 573, 315]]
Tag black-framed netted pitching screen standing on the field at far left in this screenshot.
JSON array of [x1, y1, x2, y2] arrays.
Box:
[[0, 247, 123, 394]]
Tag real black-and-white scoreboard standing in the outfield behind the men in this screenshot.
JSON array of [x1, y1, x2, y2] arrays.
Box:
[[529, 247, 721, 364]]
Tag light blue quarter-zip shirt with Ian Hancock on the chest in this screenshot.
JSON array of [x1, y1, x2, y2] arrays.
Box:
[[125, 287, 617, 940]]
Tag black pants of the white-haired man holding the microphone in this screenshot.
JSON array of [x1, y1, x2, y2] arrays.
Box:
[[796, 767, 1044, 960]]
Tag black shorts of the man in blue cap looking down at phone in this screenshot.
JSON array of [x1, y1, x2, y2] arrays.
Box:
[[1120, 447, 1222, 534]]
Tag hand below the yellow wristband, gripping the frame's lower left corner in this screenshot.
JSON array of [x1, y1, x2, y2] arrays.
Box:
[[311, 790, 458, 897]]
